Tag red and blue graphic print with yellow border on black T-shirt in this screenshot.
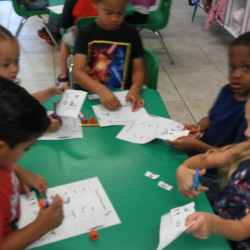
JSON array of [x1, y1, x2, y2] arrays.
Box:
[[87, 41, 131, 89]]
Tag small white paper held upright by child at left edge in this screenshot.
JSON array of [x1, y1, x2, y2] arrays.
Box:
[[57, 89, 87, 118]]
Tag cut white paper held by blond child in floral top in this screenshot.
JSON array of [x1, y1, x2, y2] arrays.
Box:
[[157, 202, 195, 250]]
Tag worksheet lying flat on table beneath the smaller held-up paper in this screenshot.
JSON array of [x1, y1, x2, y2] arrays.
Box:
[[38, 111, 83, 140]]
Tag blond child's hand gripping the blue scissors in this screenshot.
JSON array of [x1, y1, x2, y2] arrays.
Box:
[[176, 165, 209, 198]]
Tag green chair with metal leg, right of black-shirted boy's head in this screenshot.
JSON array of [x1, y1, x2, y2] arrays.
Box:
[[135, 0, 174, 64]]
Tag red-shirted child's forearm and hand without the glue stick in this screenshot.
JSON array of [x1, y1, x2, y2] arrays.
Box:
[[13, 164, 48, 197]]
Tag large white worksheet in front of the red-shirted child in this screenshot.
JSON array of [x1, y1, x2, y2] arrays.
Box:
[[19, 177, 121, 249]]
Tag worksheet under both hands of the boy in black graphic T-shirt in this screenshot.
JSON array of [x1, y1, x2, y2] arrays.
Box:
[[92, 102, 148, 127]]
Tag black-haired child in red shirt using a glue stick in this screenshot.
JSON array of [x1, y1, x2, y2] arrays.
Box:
[[0, 78, 63, 249]]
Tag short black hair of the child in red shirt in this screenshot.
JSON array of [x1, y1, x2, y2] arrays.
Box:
[[0, 77, 50, 148]]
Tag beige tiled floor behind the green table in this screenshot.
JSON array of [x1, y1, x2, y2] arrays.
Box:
[[0, 0, 233, 123]]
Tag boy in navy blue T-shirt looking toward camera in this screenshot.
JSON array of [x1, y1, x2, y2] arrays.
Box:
[[168, 32, 250, 203]]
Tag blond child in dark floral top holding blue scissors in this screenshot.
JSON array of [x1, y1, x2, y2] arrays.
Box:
[[176, 95, 250, 249]]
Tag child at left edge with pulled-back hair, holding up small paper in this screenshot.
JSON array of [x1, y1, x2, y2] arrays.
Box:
[[0, 25, 69, 132]]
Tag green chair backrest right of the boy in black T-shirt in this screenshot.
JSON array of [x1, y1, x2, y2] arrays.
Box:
[[143, 47, 159, 90]]
